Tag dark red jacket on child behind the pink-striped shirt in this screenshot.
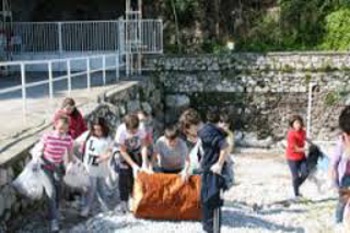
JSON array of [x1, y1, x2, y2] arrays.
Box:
[[53, 110, 87, 139]]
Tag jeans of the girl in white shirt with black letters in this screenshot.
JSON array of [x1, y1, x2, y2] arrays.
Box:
[[82, 177, 108, 211]]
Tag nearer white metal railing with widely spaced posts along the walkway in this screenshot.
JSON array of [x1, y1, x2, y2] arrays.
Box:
[[0, 53, 125, 121]]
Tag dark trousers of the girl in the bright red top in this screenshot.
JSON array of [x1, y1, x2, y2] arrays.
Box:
[[288, 159, 308, 196]]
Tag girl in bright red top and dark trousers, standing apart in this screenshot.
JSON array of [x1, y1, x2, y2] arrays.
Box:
[[286, 115, 308, 198]]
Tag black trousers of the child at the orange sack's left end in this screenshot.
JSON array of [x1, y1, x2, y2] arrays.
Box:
[[119, 168, 134, 201]]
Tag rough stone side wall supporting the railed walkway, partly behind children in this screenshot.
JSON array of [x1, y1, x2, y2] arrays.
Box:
[[0, 82, 163, 232]]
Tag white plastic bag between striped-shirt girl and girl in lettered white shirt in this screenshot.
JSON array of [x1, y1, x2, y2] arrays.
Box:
[[63, 158, 90, 190]]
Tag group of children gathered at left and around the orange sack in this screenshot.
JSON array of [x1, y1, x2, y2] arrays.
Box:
[[34, 98, 233, 232]]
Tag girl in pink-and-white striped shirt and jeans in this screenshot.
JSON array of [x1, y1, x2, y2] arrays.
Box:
[[40, 115, 73, 232]]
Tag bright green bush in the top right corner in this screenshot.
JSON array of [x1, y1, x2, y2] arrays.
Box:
[[321, 8, 350, 50]]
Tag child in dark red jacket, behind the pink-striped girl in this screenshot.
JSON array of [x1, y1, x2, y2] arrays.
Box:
[[54, 97, 87, 139]]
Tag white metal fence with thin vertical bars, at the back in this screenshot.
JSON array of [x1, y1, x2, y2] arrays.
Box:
[[8, 19, 163, 54]]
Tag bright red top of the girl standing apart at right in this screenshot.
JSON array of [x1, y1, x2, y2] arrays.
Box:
[[286, 129, 306, 161]]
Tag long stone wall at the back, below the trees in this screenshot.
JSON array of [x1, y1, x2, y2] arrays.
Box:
[[151, 53, 350, 140]]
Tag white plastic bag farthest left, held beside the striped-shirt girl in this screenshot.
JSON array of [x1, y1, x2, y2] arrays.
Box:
[[12, 160, 47, 200]]
